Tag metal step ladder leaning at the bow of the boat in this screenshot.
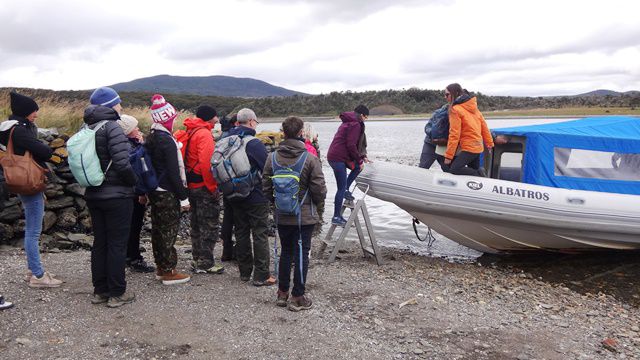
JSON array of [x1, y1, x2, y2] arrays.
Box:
[[319, 185, 382, 265]]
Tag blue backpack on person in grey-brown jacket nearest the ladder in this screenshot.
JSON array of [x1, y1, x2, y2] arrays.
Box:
[[271, 151, 308, 215]]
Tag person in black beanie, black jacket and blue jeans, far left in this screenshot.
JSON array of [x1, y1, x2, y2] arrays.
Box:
[[0, 92, 62, 288]]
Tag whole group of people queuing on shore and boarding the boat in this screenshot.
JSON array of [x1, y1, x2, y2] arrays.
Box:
[[0, 84, 494, 311]]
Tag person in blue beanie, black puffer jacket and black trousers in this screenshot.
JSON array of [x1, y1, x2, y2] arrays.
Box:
[[84, 87, 136, 307]]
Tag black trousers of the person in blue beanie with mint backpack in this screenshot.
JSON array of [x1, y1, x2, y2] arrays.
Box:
[[87, 199, 133, 297]]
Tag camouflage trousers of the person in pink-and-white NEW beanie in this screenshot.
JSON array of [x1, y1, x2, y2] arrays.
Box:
[[149, 191, 180, 271]]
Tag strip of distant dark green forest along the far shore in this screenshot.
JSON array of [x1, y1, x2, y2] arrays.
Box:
[[5, 88, 640, 117]]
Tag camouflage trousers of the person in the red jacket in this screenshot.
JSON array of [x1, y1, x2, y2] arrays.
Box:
[[189, 187, 220, 270]]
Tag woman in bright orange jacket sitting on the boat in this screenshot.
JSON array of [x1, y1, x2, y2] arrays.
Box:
[[444, 83, 493, 176]]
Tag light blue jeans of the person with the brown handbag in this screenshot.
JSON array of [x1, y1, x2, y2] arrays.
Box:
[[18, 193, 44, 277]]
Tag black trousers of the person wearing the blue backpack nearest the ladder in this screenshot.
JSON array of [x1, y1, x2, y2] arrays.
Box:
[[278, 225, 315, 296]]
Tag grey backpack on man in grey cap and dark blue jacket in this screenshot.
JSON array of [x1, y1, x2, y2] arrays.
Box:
[[211, 135, 260, 199]]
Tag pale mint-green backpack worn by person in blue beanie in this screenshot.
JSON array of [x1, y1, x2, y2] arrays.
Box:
[[67, 120, 111, 187]]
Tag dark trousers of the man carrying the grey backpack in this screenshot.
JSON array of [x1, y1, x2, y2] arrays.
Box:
[[230, 201, 271, 281]]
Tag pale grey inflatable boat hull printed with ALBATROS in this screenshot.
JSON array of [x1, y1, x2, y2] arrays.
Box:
[[357, 163, 640, 253]]
